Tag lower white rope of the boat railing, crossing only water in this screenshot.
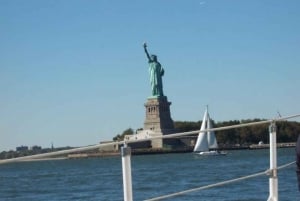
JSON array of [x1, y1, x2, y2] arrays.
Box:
[[144, 161, 296, 201]]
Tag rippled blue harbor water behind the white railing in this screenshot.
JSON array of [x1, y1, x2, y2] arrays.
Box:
[[0, 148, 300, 201]]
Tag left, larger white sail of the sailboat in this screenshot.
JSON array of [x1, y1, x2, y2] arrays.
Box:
[[194, 109, 209, 152]]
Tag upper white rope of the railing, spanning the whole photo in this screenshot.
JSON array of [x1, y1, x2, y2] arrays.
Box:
[[0, 114, 300, 165]]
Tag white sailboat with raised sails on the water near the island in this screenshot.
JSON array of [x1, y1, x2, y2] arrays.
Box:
[[194, 107, 226, 155]]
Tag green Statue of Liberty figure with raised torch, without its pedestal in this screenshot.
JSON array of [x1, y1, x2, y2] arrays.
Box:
[[144, 43, 164, 97]]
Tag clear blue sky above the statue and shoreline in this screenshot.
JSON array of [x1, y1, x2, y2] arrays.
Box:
[[0, 0, 300, 151]]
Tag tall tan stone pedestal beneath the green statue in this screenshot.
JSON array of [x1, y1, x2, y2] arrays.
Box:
[[144, 96, 174, 148]]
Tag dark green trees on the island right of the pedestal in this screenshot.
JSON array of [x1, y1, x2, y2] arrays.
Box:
[[174, 119, 300, 145]]
